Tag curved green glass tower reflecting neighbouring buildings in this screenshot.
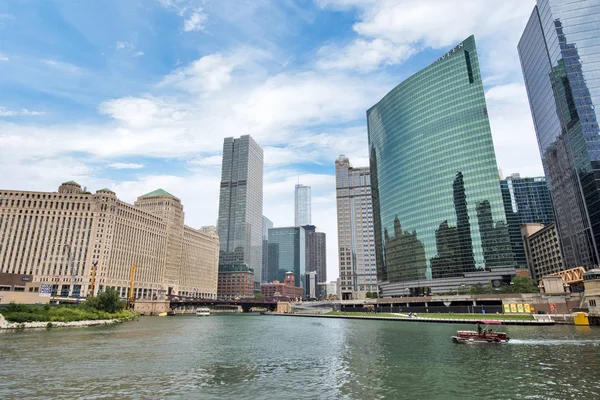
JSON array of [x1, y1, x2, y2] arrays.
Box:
[[367, 36, 515, 296]]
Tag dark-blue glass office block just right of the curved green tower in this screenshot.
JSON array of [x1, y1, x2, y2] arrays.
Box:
[[500, 174, 554, 268]]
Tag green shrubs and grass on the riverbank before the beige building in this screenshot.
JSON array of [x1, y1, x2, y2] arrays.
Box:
[[0, 289, 137, 329]]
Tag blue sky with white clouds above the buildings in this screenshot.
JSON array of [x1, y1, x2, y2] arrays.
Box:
[[0, 0, 543, 280]]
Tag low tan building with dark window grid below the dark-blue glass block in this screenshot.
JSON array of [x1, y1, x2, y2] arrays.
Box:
[[521, 224, 565, 281]]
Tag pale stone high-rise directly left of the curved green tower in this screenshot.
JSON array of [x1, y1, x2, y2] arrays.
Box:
[[335, 154, 378, 300]]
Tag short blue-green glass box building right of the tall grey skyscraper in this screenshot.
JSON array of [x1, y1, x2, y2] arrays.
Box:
[[268, 226, 306, 288]]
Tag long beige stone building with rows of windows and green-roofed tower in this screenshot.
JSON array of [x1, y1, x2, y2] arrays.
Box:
[[0, 182, 219, 299]]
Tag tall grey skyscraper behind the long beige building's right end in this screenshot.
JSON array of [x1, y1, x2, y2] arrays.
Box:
[[217, 135, 263, 291]]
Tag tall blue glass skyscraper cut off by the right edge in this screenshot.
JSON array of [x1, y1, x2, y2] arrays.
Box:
[[518, 0, 600, 268]]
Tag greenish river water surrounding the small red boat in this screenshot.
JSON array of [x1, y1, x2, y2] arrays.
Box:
[[0, 315, 600, 400]]
